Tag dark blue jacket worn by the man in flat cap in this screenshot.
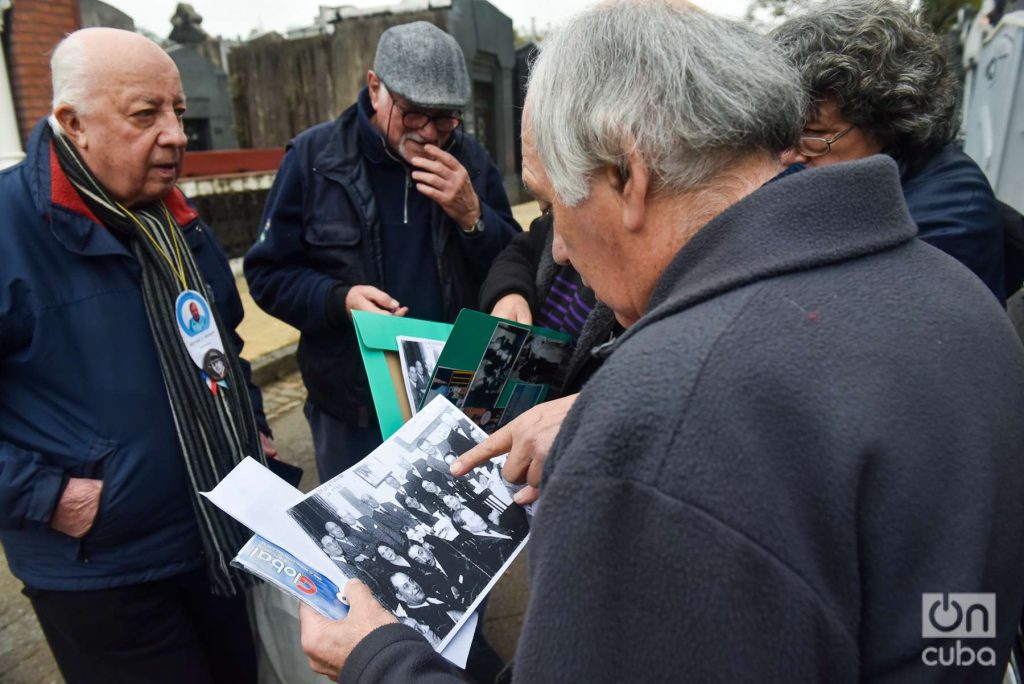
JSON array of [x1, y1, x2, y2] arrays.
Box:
[[245, 94, 519, 421]]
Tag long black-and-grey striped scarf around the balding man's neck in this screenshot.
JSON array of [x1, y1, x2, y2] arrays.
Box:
[[51, 124, 266, 596]]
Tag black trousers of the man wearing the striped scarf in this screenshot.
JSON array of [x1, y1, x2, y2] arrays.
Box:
[[24, 569, 256, 684]]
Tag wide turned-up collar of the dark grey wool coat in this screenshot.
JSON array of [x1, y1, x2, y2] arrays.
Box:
[[624, 155, 918, 338]]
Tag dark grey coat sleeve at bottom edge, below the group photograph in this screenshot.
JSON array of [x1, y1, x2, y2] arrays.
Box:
[[338, 625, 465, 684]]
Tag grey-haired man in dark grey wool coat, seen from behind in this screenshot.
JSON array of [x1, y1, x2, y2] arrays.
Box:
[[294, 0, 1024, 684]]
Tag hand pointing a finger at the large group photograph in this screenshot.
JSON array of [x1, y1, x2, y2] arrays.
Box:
[[452, 394, 579, 505]]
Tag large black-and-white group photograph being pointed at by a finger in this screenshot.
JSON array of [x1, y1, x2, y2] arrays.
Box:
[[288, 398, 529, 651]]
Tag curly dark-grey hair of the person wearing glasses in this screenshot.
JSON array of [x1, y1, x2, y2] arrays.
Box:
[[771, 0, 959, 164]]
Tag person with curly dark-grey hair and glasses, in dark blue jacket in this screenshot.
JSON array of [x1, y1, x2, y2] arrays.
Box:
[[772, 0, 1006, 302]]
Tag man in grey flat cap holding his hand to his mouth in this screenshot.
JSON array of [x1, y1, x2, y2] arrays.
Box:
[[245, 22, 519, 480]]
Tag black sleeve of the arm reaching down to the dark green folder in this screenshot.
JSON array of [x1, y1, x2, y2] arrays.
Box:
[[480, 214, 551, 314]]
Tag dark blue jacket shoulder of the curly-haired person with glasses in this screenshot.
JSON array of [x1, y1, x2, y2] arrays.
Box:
[[900, 144, 1007, 303]]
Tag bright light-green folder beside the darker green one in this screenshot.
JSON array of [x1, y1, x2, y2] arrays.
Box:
[[352, 311, 452, 439]]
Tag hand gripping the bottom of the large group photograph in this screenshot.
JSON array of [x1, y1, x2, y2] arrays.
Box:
[[299, 580, 398, 681]]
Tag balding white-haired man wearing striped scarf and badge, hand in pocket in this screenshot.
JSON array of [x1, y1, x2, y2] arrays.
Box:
[[0, 29, 269, 684]]
